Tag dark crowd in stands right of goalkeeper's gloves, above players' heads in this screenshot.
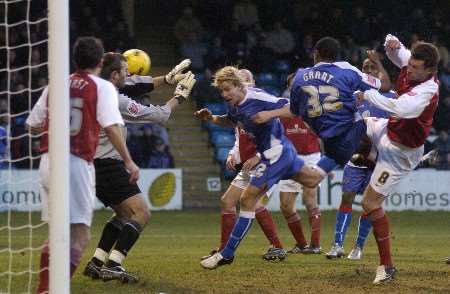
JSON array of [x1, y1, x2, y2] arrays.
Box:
[[173, 0, 450, 169]]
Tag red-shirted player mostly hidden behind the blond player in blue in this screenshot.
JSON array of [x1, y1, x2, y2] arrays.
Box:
[[202, 69, 286, 260]]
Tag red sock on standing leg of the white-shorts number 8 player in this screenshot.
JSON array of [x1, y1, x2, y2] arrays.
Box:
[[368, 207, 392, 267]]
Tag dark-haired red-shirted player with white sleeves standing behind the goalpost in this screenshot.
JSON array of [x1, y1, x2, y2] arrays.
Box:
[[26, 37, 139, 293]]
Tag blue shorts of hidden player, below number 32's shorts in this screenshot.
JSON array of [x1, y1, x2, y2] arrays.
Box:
[[342, 164, 373, 194]]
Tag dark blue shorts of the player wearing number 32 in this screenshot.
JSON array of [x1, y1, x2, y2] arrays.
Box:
[[322, 120, 367, 166]]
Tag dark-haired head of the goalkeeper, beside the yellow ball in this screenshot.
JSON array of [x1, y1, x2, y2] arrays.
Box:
[[100, 52, 128, 88]]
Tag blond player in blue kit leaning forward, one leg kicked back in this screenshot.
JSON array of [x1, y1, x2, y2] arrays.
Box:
[[195, 66, 321, 269]]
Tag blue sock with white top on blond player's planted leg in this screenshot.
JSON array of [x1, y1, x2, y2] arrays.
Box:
[[220, 211, 255, 259]]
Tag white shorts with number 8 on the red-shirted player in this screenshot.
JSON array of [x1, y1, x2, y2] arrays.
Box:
[[366, 117, 424, 196]]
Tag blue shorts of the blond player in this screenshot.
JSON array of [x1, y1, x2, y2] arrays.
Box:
[[250, 144, 305, 189]]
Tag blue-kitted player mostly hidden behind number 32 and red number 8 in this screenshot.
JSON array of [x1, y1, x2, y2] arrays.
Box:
[[326, 50, 396, 259]]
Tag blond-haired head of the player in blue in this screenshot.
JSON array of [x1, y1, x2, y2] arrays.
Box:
[[213, 66, 247, 105]]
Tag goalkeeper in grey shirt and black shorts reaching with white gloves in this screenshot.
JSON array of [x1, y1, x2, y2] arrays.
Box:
[[83, 53, 196, 283]]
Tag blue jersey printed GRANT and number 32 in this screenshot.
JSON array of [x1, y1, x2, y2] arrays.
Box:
[[290, 62, 381, 138]]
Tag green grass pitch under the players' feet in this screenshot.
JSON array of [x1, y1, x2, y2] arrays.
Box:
[[0, 210, 450, 294]]
